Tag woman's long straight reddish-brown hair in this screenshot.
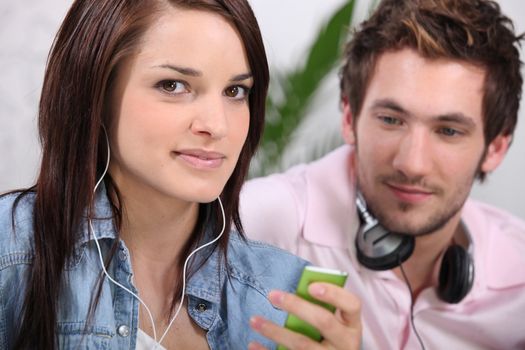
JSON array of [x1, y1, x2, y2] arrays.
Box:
[[13, 0, 269, 349]]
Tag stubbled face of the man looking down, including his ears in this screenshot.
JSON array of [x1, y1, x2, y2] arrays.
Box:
[[344, 49, 507, 235]]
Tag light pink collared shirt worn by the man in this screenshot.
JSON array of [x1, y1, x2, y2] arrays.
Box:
[[241, 146, 525, 350]]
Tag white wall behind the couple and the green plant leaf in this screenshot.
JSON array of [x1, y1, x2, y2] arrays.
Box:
[[0, 0, 525, 219]]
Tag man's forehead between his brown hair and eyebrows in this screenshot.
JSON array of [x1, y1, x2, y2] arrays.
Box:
[[363, 49, 485, 123]]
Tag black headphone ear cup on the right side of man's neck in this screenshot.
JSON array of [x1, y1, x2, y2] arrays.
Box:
[[437, 245, 474, 304]]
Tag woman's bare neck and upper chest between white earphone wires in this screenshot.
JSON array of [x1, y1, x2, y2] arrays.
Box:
[[115, 186, 199, 327]]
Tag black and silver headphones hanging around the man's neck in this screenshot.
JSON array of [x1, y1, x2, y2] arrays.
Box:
[[355, 193, 474, 304]]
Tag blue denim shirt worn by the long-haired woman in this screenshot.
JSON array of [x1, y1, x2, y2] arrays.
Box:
[[0, 191, 306, 349]]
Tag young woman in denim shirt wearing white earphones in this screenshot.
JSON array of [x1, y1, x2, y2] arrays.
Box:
[[0, 0, 358, 349]]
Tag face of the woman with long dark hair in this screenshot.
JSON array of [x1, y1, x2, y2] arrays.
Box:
[[109, 7, 253, 202]]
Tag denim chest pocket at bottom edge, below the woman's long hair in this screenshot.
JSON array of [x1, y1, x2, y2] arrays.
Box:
[[57, 322, 115, 350]]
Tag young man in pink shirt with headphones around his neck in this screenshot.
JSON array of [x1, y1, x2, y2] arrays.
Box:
[[241, 0, 525, 349]]
